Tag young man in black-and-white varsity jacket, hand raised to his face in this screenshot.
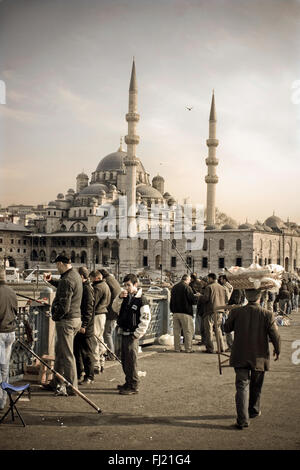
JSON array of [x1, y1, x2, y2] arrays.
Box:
[[112, 274, 151, 395]]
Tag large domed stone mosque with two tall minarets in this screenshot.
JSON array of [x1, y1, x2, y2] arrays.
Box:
[[26, 61, 300, 278]]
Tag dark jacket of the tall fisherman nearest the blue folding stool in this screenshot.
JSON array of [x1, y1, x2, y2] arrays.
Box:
[[50, 268, 82, 321]]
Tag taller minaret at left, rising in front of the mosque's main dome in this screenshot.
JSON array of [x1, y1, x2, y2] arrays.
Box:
[[124, 59, 140, 236]]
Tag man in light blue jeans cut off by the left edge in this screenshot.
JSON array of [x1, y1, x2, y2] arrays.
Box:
[[0, 268, 18, 410]]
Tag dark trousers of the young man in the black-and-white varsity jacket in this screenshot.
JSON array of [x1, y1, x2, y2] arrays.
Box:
[[121, 335, 139, 389]]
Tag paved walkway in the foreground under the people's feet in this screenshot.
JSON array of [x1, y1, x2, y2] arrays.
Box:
[[0, 313, 300, 450]]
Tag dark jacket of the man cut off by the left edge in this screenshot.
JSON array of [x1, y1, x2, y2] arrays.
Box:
[[0, 281, 18, 333]]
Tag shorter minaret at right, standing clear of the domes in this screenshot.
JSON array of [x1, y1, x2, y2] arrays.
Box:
[[205, 91, 219, 225]]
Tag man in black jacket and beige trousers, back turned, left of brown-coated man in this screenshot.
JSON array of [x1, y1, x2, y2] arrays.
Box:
[[170, 274, 200, 353]]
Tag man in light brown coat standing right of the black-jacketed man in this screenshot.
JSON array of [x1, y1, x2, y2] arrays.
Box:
[[198, 273, 226, 354]]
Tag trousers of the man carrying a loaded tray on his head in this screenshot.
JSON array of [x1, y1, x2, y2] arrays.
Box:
[[235, 367, 265, 426]]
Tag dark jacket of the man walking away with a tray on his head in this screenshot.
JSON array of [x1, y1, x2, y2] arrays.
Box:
[[224, 302, 280, 371]]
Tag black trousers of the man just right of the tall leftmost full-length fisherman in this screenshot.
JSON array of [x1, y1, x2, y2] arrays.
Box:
[[74, 333, 96, 380]]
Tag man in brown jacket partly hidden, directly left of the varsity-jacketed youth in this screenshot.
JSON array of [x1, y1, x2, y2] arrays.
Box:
[[99, 269, 122, 361]]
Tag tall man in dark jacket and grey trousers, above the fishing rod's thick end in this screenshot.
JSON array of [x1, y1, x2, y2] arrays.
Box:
[[44, 255, 82, 396]]
